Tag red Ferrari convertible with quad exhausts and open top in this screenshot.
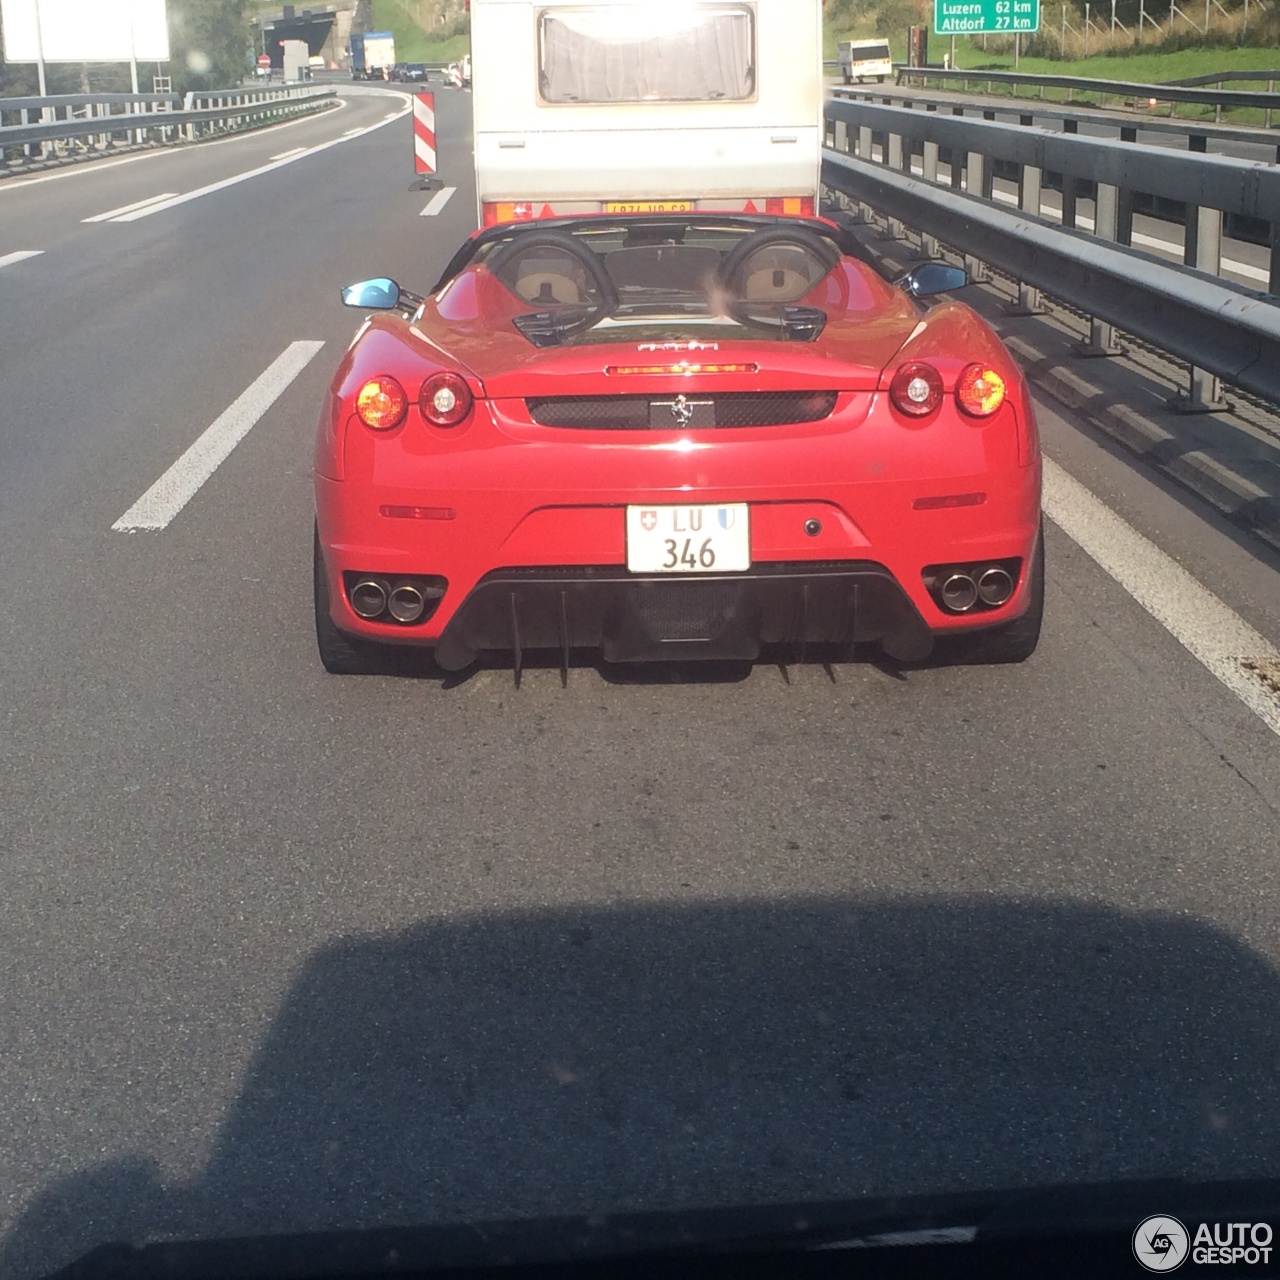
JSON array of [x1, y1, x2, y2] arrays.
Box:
[[315, 212, 1044, 673]]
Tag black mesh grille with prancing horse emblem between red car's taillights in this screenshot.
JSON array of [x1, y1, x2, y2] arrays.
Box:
[[525, 392, 838, 431]]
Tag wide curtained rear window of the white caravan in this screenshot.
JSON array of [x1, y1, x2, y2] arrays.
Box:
[[538, 3, 755, 102]]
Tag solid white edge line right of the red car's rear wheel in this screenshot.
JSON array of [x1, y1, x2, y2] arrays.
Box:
[[1044, 458, 1280, 735]]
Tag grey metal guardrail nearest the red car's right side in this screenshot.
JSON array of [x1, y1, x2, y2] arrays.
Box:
[[823, 100, 1280, 410]]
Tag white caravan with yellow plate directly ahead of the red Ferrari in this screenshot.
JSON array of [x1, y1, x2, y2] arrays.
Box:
[[471, 0, 823, 227]]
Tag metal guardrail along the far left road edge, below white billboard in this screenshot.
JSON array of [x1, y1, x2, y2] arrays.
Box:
[[0, 84, 337, 173]]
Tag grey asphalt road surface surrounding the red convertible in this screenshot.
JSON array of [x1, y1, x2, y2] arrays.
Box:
[[0, 82, 1280, 1277]]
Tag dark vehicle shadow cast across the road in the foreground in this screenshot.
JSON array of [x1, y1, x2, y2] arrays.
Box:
[[0, 899, 1280, 1276]]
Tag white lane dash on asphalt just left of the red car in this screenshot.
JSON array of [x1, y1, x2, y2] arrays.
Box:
[[111, 342, 324, 532]]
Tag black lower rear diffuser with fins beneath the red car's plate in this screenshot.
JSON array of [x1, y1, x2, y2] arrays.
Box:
[[435, 561, 933, 669]]
